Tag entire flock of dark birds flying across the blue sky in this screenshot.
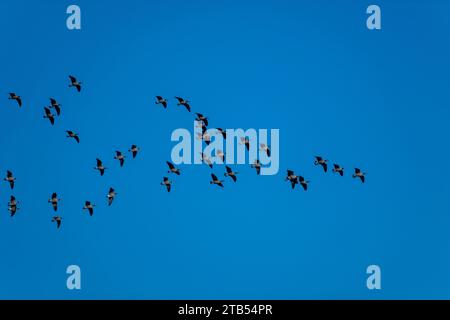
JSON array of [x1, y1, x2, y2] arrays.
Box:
[[3, 76, 366, 228]]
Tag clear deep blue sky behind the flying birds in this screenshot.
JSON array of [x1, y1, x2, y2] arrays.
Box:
[[0, 0, 450, 299]]
